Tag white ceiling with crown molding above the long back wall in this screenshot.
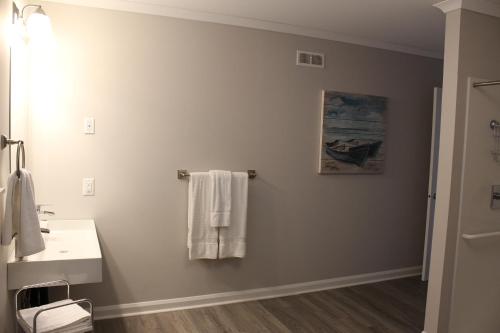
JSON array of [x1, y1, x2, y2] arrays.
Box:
[[47, 0, 444, 58]]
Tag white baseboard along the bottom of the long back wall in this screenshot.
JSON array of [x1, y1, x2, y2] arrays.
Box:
[[94, 266, 422, 320]]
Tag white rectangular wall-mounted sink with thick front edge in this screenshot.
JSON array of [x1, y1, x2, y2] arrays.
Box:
[[7, 220, 102, 289]]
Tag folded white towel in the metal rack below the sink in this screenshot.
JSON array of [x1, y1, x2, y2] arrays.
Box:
[[19, 299, 91, 333]]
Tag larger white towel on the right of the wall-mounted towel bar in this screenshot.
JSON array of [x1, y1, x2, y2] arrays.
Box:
[[219, 172, 248, 259]]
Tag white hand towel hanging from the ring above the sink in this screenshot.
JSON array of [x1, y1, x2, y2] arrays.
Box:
[[2, 169, 45, 257]]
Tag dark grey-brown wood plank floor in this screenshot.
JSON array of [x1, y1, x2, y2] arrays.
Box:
[[95, 277, 427, 333]]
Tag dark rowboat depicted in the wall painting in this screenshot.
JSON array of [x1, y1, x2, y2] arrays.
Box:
[[326, 139, 382, 167]]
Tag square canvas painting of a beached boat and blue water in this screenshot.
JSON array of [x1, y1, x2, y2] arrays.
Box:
[[319, 91, 387, 174]]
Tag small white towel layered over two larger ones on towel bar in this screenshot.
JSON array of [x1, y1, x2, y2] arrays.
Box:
[[208, 170, 231, 227]]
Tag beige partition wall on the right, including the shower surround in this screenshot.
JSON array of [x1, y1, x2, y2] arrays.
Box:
[[425, 10, 500, 333]]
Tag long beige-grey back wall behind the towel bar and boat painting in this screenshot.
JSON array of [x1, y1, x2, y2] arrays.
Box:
[[28, 3, 442, 305]]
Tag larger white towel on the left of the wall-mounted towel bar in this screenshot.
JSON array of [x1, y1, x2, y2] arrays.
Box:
[[187, 172, 218, 260]]
